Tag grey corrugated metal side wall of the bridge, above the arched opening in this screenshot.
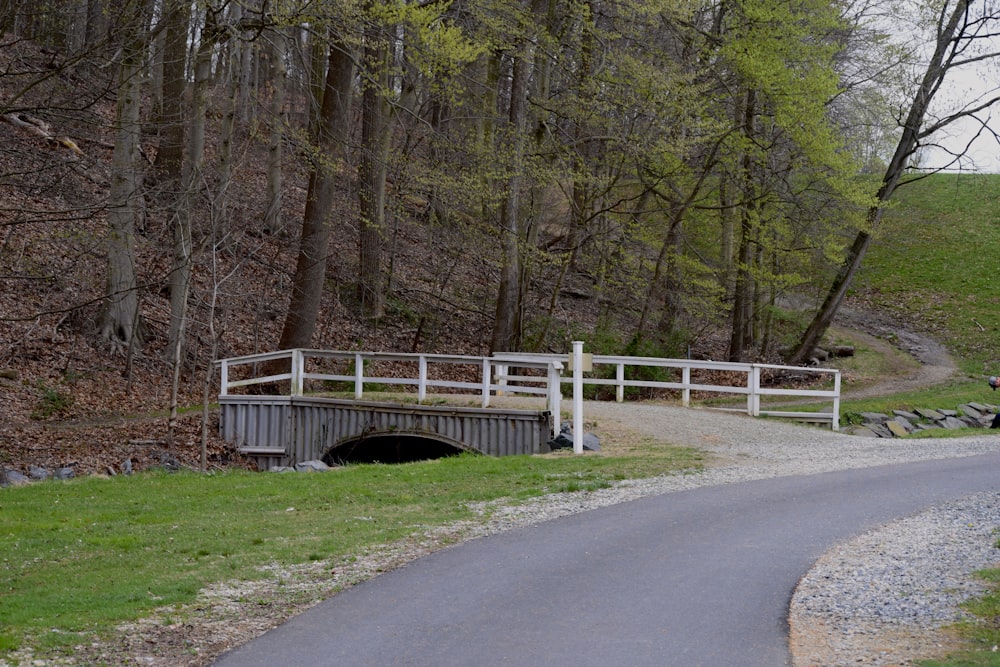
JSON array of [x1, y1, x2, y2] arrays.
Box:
[[219, 395, 553, 470]]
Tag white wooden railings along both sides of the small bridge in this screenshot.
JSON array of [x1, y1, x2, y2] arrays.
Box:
[[216, 343, 840, 431]]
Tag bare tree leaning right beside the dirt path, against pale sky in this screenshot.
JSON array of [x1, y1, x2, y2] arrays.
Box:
[[788, 0, 1000, 364]]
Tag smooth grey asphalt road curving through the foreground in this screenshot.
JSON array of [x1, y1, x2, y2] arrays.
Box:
[[215, 454, 1000, 667]]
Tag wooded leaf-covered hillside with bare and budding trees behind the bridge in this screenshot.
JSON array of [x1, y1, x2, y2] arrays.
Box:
[[0, 0, 1000, 470]]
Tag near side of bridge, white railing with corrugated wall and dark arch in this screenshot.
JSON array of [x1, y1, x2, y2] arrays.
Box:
[[219, 350, 562, 470]]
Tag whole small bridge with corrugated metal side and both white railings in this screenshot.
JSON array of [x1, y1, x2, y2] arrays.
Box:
[[217, 350, 840, 470]]
